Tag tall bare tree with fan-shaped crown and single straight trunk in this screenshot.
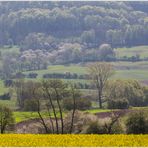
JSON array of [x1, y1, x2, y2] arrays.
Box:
[[88, 62, 114, 108]]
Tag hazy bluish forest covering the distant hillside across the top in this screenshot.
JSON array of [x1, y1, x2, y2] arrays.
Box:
[[0, 1, 148, 50]]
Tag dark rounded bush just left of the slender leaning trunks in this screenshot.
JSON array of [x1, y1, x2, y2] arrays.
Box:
[[24, 99, 38, 111]]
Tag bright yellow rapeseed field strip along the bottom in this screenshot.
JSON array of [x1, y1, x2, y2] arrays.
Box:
[[0, 134, 148, 147]]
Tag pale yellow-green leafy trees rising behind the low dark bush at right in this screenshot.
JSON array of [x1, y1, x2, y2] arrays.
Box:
[[108, 80, 144, 106]]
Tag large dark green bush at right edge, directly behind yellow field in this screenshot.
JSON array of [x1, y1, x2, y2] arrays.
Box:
[[126, 112, 148, 134]]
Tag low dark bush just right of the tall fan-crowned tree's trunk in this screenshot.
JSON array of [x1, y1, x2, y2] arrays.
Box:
[[108, 99, 129, 109]]
